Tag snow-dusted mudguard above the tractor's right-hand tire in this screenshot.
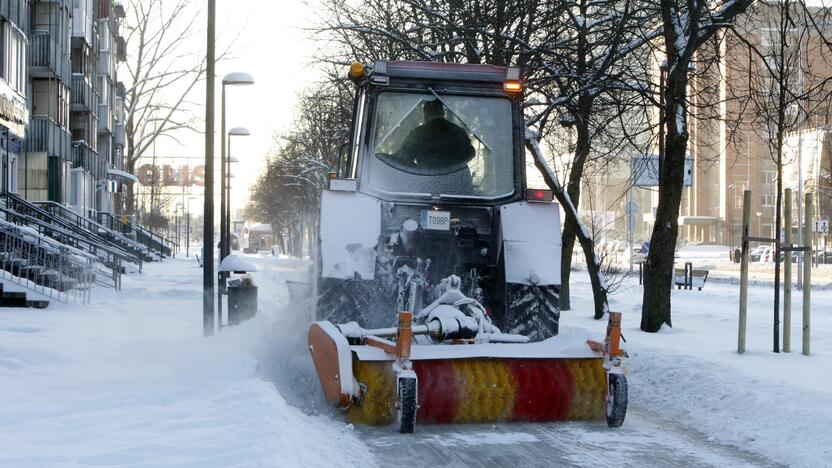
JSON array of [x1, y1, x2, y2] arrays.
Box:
[[500, 202, 561, 286]]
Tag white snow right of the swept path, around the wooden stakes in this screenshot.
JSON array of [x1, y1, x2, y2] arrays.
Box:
[[561, 272, 832, 466]]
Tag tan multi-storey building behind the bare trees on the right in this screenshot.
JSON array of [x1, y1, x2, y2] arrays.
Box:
[[579, 3, 832, 246]]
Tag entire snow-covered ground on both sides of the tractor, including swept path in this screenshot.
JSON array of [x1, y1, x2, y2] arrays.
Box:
[[0, 257, 832, 467]]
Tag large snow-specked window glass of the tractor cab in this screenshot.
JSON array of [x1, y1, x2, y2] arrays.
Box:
[[368, 92, 514, 197]]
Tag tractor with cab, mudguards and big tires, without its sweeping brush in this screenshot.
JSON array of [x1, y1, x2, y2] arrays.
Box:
[[318, 61, 560, 339]]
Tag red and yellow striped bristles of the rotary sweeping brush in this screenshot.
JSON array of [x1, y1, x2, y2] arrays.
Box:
[[347, 358, 606, 425]]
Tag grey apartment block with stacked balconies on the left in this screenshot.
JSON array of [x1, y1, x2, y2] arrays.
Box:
[[0, 0, 127, 218]]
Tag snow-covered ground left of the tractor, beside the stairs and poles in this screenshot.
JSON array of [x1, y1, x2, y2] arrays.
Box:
[[0, 258, 374, 467]]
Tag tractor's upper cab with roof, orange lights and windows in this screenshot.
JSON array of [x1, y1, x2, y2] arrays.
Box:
[[341, 62, 523, 205]]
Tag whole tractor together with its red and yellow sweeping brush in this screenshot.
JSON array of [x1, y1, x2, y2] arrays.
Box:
[[308, 62, 627, 432]]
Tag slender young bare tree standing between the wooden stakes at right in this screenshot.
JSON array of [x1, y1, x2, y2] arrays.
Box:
[[730, 0, 832, 350]]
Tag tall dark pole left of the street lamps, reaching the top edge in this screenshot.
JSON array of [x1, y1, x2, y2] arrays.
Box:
[[202, 0, 217, 336]]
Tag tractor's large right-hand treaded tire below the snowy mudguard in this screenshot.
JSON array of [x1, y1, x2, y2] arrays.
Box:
[[504, 283, 560, 341]]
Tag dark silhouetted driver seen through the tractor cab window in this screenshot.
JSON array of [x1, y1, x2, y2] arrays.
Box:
[[397, 99, 474, 174]]
